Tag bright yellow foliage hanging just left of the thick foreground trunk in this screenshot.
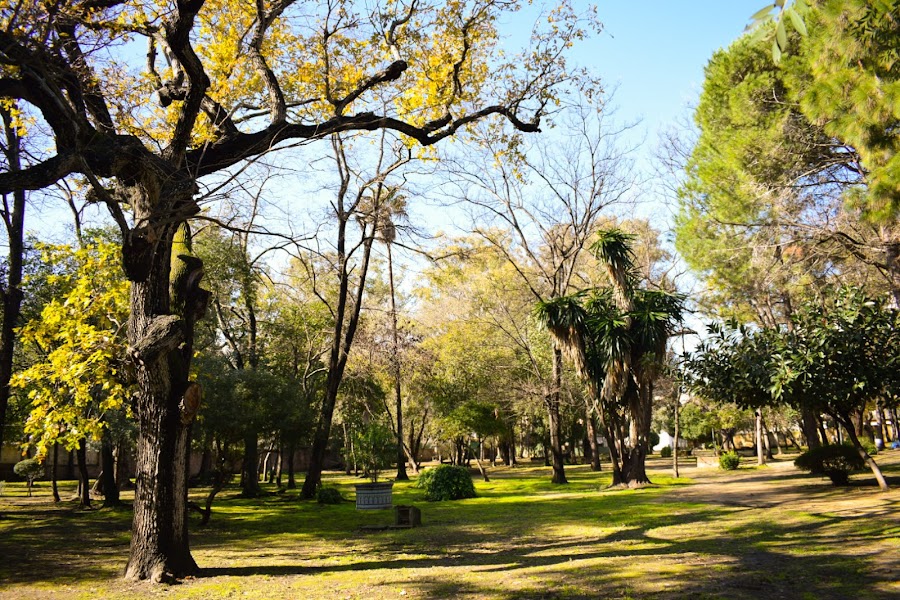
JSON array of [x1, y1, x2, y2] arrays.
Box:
[[10, 243, 131, 452]]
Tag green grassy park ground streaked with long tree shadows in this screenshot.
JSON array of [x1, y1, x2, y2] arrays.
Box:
[[0, 452, 900, 600]]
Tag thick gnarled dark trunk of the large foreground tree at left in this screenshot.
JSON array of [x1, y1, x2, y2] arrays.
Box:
[[123, 186, 208, 582]]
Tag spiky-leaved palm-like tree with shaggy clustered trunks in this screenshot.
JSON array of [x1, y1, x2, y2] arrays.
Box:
[[537, 230, 683, 485]]
